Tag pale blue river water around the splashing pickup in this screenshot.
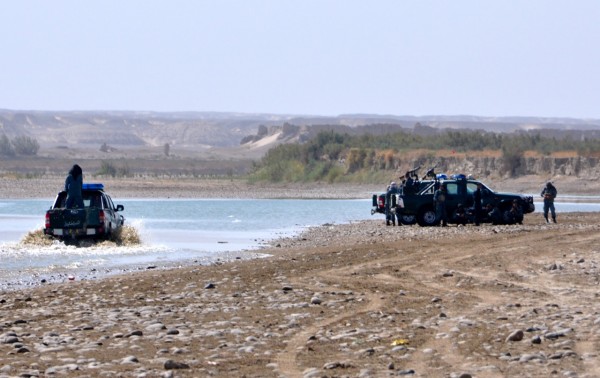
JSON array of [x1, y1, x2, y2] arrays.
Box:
[[0, 195, 600, 284]]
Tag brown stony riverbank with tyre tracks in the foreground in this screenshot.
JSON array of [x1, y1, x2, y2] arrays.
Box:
[[0, 213, 600, 377]]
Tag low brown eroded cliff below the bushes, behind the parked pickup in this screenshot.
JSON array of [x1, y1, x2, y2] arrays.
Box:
[[399, 156, 600, 179]]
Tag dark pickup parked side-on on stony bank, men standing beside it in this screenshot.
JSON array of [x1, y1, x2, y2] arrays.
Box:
[[392, 175, 535, 226]]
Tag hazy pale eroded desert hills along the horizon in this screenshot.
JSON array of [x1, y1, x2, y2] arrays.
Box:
[[0, 109, 600, 155]]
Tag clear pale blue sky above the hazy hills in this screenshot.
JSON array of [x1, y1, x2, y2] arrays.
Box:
[[0, 0, 600, 119]]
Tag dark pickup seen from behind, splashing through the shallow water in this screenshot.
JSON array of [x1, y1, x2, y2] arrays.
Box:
[[44, 183, 125, 241]]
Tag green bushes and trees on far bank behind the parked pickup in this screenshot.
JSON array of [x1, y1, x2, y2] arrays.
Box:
[[251, 130, 600, 182]]
